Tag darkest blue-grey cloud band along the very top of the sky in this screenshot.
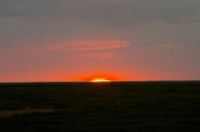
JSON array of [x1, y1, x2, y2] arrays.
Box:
[[0, 0, 200, 27]]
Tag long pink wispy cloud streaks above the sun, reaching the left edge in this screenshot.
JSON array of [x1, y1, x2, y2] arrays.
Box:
[[0, 40, 130, 59]]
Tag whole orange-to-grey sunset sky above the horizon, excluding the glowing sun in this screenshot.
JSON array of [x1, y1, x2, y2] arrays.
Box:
[[0, 0, 200, 82]]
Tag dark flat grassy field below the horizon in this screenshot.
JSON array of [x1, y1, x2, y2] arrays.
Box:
[[0, 81, 200, 132]]
